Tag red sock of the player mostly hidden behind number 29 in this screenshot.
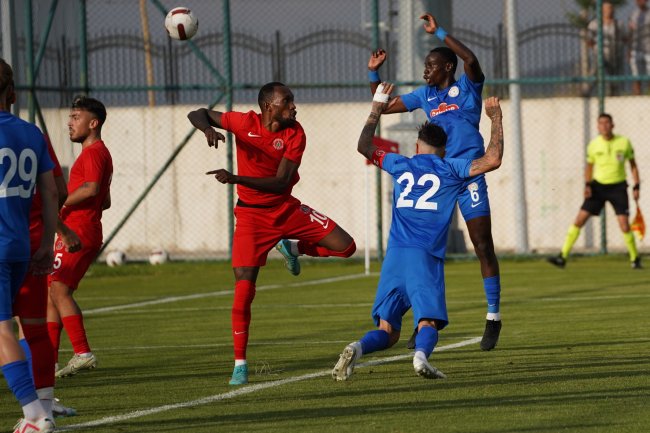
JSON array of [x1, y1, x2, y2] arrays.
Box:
[[23, 323, 54, 389]]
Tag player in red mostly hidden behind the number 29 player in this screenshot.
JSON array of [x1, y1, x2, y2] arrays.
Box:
[[13, 136, 81, 418]]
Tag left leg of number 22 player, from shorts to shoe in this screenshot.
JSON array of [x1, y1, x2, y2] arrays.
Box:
[[332, 251, 402, 381]]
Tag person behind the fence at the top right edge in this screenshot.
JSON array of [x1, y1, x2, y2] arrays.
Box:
[[629, 0, 650, 95]]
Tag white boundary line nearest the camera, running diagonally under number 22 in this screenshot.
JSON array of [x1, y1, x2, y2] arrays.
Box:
[[57, 337, 481, 432]]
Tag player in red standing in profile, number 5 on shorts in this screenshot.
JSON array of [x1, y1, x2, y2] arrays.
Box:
[[47, 96, 113, 377]]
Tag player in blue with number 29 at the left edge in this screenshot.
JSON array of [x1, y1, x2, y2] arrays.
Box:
[[0, 59, 58, 433]]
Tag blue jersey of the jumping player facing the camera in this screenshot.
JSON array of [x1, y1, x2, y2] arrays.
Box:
[[400, 74, 485, 159]]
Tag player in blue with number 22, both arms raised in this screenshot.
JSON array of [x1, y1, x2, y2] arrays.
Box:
[[332, 84, 503, 380]]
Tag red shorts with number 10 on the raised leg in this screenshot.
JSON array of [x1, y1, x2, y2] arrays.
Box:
[[232, 197, 337, 268]]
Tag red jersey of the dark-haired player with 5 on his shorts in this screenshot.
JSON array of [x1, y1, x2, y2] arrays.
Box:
[[61, 140, 113, 229]]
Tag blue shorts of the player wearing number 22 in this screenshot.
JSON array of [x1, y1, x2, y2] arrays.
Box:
[[372, 247, 449, 331]]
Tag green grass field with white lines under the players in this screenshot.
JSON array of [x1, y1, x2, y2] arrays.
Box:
[[0, 256, 650, 433]]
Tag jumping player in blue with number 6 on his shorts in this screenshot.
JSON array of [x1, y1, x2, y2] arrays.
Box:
[[368, 13, 501, 350]]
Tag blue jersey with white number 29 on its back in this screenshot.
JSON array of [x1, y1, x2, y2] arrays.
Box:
[[0, 111, 54, 263]]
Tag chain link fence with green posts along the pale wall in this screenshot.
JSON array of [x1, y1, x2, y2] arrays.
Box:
[[2, 0, 650, 259]]
